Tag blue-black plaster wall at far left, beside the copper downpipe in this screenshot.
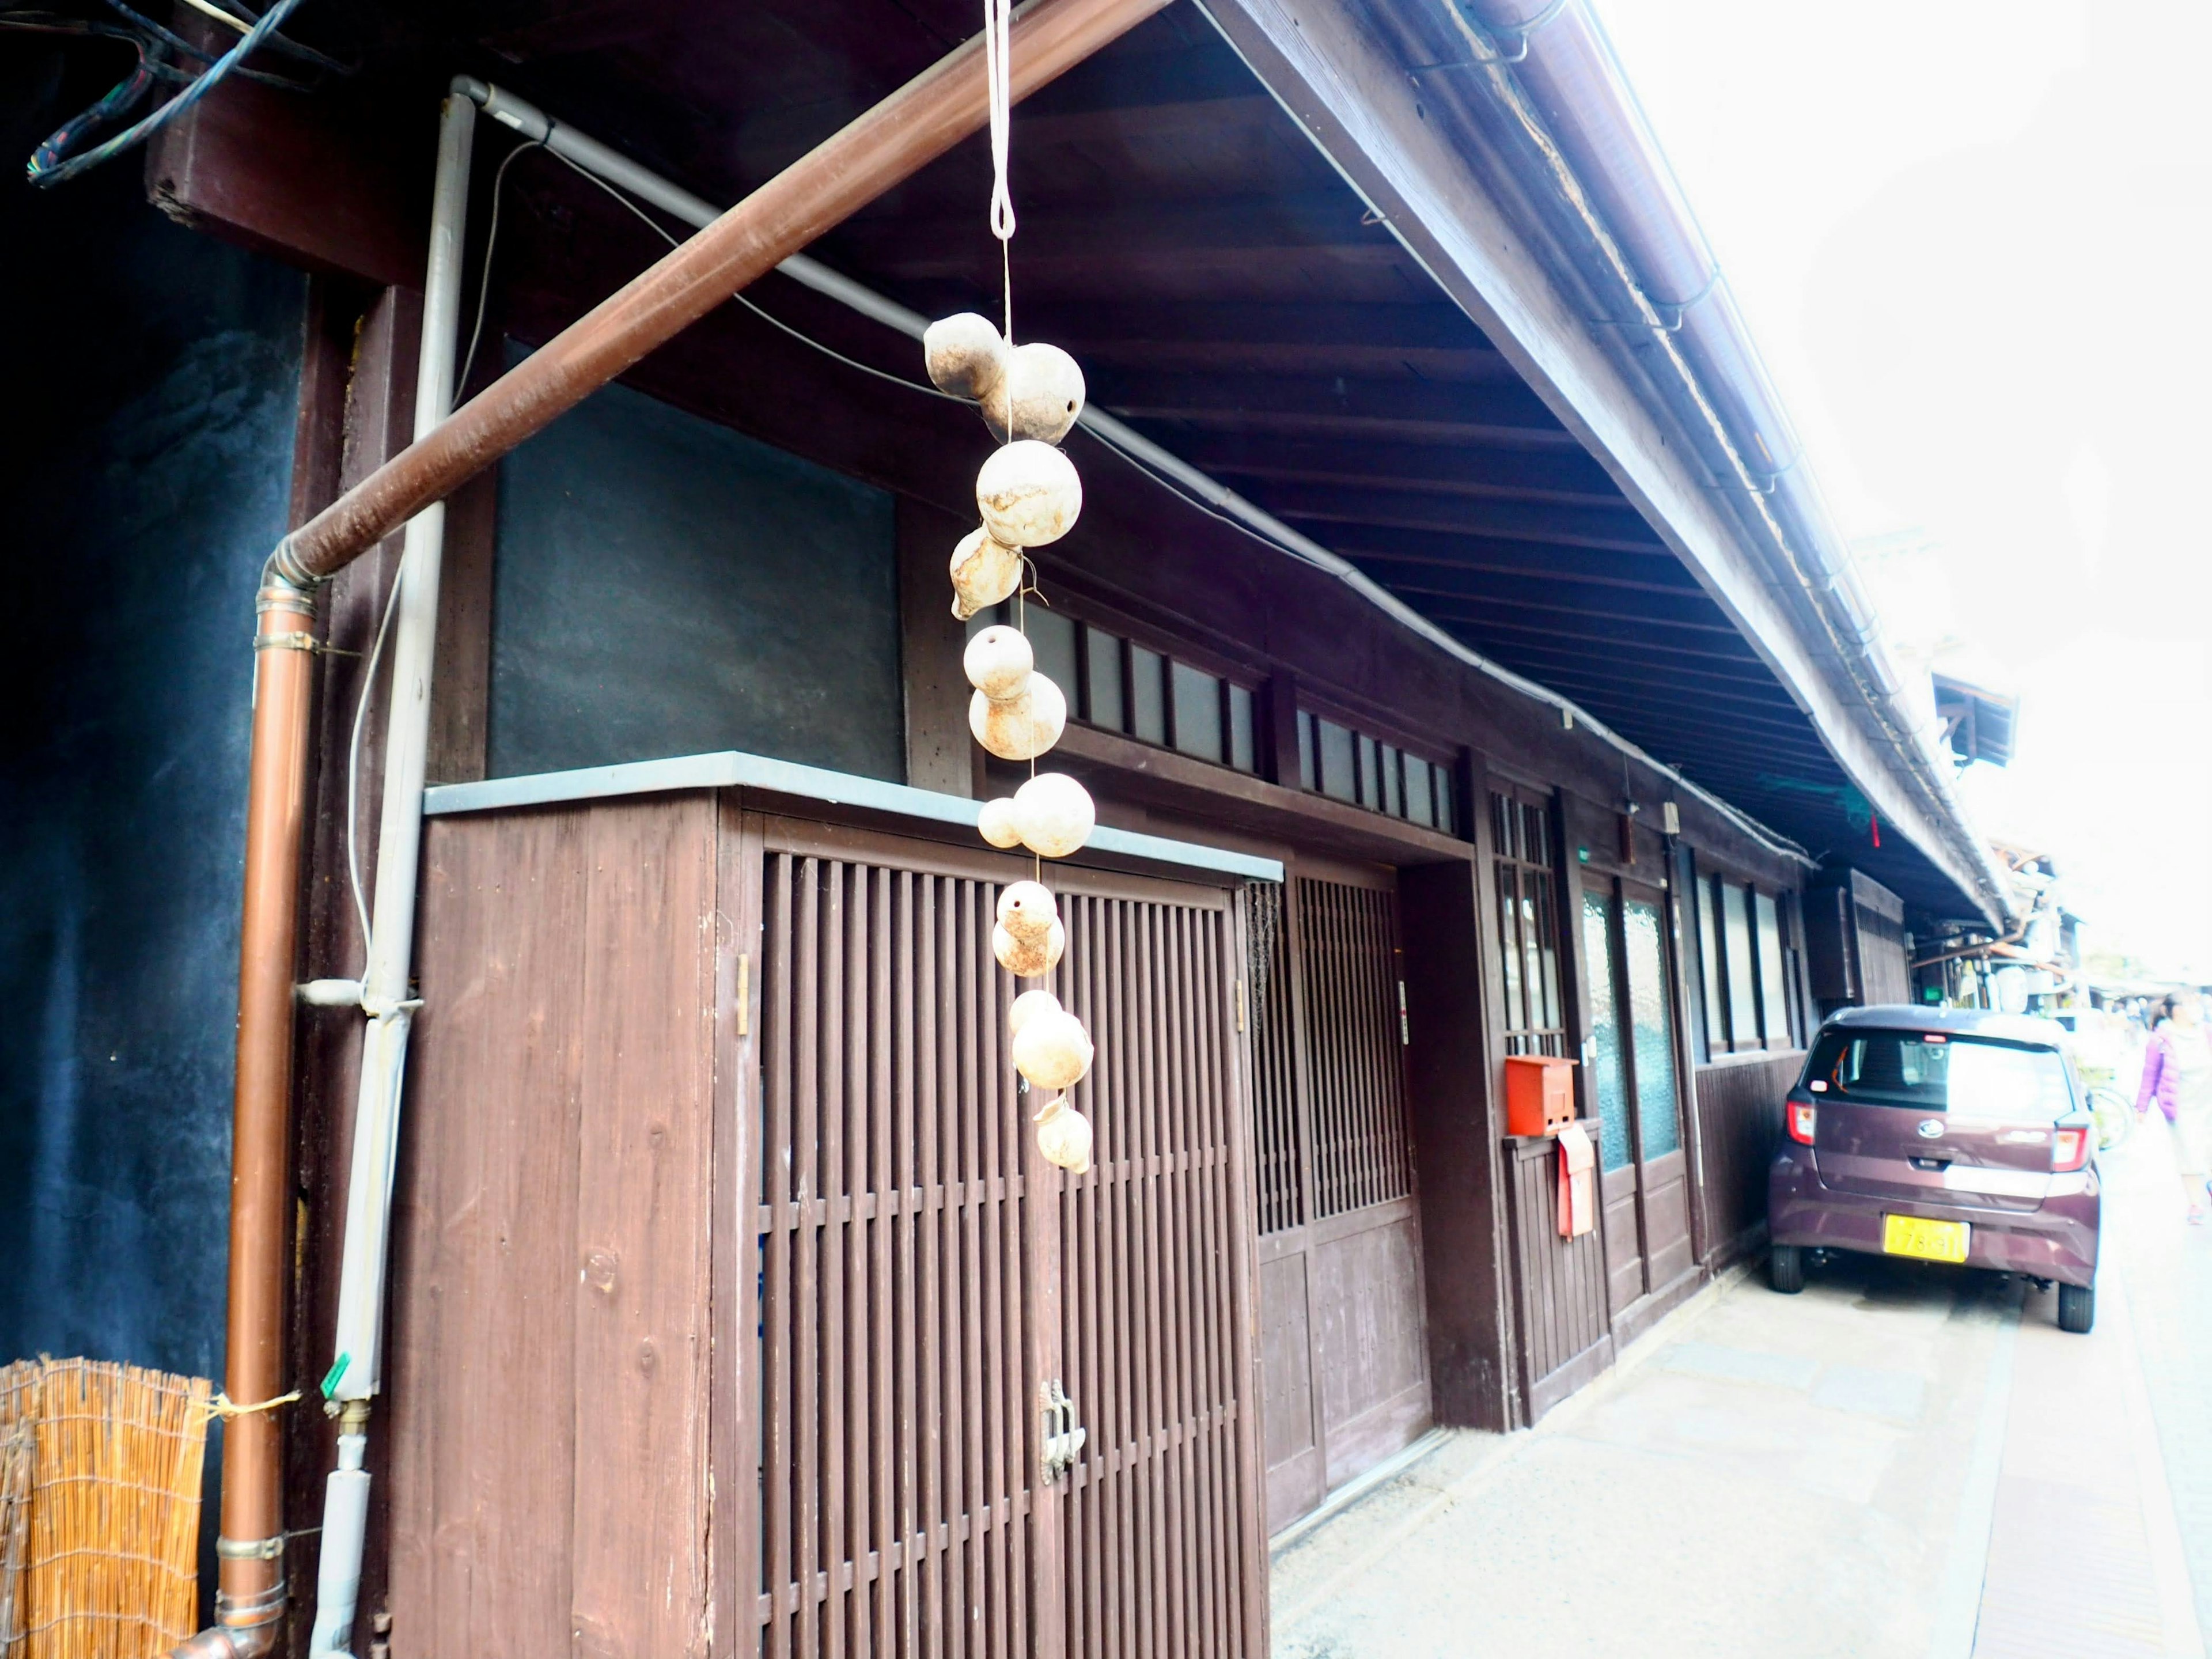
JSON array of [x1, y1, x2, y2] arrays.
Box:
[[0, 123, 303, 1376]]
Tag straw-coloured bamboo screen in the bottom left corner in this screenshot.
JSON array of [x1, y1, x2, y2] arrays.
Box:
[[0, 1358, 213, 1659]]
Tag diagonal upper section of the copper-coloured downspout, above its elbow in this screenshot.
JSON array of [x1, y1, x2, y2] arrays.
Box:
[[274, 0, 1168, 579]]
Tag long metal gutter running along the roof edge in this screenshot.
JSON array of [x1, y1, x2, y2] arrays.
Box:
[[1433, 0, 2013, 920]]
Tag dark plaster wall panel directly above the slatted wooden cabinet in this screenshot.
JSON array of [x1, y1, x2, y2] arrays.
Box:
[[489, 367, 905, 783]]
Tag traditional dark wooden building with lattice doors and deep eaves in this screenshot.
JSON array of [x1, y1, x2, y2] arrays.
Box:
[[0, 0, 2009, 1659]]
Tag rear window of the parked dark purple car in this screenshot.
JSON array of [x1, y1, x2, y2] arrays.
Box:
[[1805, 1031, 2073, 1124]]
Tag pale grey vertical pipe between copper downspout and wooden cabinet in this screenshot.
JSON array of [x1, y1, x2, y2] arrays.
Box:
[[308, 82, 476, 1659]]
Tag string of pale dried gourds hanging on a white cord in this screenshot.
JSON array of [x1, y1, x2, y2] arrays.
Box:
[[922, 0, 1097, 1175]]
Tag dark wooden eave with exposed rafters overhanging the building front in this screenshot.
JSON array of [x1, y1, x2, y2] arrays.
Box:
[[153, 0, 1971, 914]]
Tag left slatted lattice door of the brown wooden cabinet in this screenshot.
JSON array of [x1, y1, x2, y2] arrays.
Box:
[[748, 845, 1040, 1659]]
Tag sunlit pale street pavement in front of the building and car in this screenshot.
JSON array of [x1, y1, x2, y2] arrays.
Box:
[[1272, 1115, 2212, 1659]]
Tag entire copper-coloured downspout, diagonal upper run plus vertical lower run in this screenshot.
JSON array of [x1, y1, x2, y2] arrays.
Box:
[[177, 0, 1170, 1659]]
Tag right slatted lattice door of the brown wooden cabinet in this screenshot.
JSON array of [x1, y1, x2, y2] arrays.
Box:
[[1058, 880, 1267, 1659]]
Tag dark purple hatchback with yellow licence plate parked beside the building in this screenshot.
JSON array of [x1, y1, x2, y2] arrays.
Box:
[[1767, 1006, 2101, 1332]]
